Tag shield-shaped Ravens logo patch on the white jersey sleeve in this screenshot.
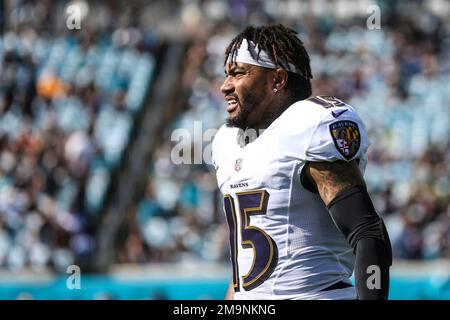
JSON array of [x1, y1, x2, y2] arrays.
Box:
[[330, 120, 361, 160]]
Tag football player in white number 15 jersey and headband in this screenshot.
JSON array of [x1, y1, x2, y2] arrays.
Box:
[[212, 25, 392, 299]]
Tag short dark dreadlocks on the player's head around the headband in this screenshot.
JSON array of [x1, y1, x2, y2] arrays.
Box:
[[224, 24, 312, 100]]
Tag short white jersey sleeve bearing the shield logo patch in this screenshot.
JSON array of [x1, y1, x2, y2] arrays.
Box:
[[305, 105, 370, 162]]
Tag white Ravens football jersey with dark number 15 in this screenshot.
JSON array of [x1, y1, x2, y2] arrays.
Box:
[[212, 96, 369, 299]]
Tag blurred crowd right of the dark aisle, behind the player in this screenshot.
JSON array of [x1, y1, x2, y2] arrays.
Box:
[[118, 1, 450, 263]]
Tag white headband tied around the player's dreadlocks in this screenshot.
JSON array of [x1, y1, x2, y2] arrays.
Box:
[[228, 39, 299, 73]]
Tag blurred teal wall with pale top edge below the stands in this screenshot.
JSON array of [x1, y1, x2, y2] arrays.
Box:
[[0, 261, 450, 300]]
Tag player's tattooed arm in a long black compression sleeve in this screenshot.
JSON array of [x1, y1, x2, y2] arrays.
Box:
[[304, 161, 392, 299]]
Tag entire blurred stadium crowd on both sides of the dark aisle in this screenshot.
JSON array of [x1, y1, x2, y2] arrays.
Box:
[[0, 0, 450, 271]]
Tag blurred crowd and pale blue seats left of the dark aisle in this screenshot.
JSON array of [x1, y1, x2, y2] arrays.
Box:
[[0, 1, 157, 272]]
